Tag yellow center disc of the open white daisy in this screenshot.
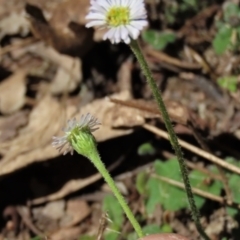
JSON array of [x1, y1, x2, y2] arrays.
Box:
[[106, 7, 130, 27]]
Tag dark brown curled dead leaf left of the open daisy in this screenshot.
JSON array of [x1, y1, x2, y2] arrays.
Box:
[[26, 1, 93, 56]]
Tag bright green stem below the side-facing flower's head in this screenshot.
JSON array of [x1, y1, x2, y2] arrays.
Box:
[[88, 149, 144, 238]]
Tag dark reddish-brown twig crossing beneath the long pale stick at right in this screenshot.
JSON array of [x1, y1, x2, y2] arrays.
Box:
[[188, 121, 233, 201]]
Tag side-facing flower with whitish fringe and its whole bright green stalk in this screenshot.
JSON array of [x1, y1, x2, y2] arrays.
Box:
[[52, 114, 144, 238]]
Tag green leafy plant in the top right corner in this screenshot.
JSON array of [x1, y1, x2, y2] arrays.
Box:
[[213, 3, 240, 54]]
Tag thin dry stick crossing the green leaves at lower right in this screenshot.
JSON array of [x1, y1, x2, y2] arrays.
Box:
[[152, 174, 240, 209]]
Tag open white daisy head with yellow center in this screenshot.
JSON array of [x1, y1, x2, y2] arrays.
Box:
[[86, 0, 148, 44]]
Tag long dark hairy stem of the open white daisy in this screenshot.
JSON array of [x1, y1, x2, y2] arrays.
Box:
[[130, 40, 210, 240]]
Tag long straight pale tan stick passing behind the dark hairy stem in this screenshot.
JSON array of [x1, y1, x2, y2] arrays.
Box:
[[143, 124, 240, 175]]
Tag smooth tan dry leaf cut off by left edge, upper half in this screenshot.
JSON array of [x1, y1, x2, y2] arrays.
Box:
[[0, 70, 26, 114]]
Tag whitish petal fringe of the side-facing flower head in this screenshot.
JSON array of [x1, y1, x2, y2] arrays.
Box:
[[52, 113, 101, 155]]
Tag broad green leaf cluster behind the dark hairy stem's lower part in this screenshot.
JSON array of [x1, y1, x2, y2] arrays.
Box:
[[137, 159, 222, 215]]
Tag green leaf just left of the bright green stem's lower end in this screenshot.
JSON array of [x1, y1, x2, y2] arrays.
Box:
[[103, 195, 124, 231]]
